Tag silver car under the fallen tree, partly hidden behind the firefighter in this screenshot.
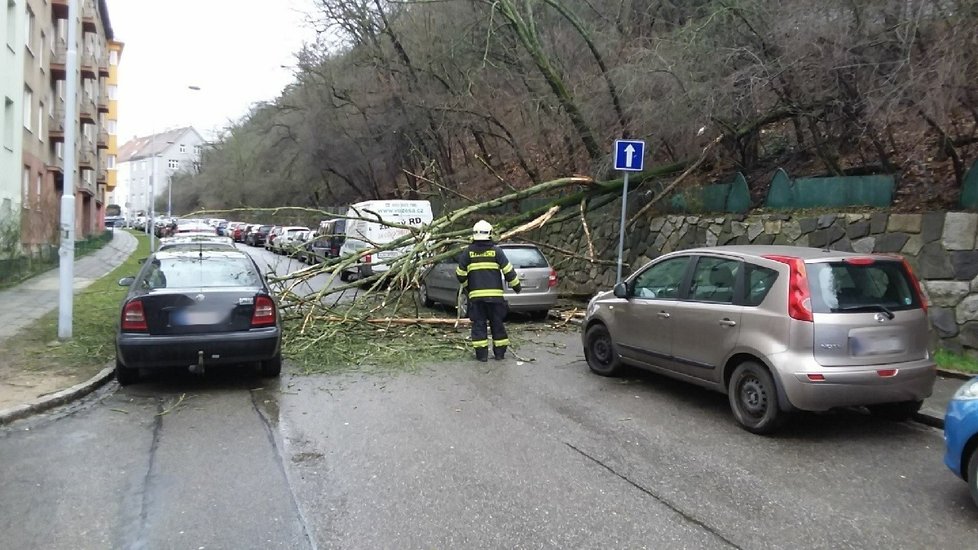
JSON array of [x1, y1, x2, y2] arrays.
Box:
[[418, 244, 557, 319]]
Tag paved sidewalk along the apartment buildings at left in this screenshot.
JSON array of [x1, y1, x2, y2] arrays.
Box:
[[0, 230, 138, 350]]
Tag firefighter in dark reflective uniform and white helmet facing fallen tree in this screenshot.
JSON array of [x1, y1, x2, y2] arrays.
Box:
[[455, 220, 522, 361]]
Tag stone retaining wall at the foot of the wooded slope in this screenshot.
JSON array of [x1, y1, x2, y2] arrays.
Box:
[[532, 209, 978, 356]]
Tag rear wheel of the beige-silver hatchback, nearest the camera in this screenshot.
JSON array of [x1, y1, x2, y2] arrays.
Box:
[[727, 361, 787, 434]]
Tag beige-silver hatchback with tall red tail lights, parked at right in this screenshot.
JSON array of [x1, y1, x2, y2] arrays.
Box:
[[582, 246, 936, 433]]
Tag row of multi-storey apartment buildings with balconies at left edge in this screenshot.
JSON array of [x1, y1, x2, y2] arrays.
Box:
[[0, 0, 115, 256]]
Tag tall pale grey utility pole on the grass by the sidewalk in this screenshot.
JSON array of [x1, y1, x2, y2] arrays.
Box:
[[58, 0, 78, 340]]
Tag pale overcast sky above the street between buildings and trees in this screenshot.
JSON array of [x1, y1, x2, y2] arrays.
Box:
[[108, 0, 314, 145]]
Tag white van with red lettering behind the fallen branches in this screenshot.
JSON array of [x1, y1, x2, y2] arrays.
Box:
[[340, 200, 433, 281]]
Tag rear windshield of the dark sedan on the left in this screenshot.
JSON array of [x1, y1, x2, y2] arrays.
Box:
[[140, 256, 261, 290]]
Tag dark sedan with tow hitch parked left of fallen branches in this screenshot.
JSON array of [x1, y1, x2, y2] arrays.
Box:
[[115, 250, 282, 385]]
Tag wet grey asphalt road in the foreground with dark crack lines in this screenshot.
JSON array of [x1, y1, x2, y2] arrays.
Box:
[[0, 248, 978, 549]]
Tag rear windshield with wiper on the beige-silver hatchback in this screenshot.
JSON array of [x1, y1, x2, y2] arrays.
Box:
[[805, 260, 920, 313]]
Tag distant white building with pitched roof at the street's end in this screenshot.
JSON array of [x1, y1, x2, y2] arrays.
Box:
[[109, 126, 204, 218]]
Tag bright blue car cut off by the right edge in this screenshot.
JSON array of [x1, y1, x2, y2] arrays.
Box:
[[944, 377, 978, 505]]
